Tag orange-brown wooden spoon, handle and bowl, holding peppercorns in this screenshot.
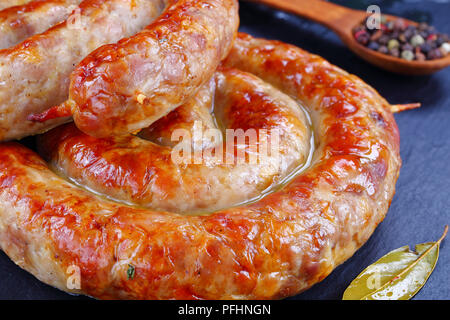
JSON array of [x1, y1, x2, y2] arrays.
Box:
[[251, 0, 450, 75]]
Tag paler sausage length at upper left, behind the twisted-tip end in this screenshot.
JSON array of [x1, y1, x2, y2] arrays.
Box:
[[0, 0, 166, 141]]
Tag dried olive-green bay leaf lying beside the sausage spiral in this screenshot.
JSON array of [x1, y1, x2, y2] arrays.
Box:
[[342, 226, 448, 300]]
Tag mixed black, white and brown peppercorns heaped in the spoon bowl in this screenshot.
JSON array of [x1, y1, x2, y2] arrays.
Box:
[[353, 16, 450, 61]]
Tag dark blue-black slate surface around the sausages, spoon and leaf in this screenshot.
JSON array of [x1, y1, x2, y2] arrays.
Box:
[[0, 0, 450, 299]]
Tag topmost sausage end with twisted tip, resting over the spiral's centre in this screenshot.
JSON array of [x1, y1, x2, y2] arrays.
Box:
[[31, 0, 239, 137]]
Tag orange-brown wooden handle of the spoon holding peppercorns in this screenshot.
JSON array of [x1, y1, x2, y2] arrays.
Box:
[[251, 0, 366, 35]]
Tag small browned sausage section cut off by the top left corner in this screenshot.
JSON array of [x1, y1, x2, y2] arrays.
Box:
[[0, 0, 81, 49]]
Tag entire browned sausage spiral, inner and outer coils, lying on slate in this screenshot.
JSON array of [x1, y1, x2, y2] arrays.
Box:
[[0, 25, 401, 299]]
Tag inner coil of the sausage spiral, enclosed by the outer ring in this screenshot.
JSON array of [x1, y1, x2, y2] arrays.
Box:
[[39, 69, 310, 214]]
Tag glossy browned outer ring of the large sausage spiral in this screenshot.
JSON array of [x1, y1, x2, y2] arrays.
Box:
[[0, 35, 400, 299]]
